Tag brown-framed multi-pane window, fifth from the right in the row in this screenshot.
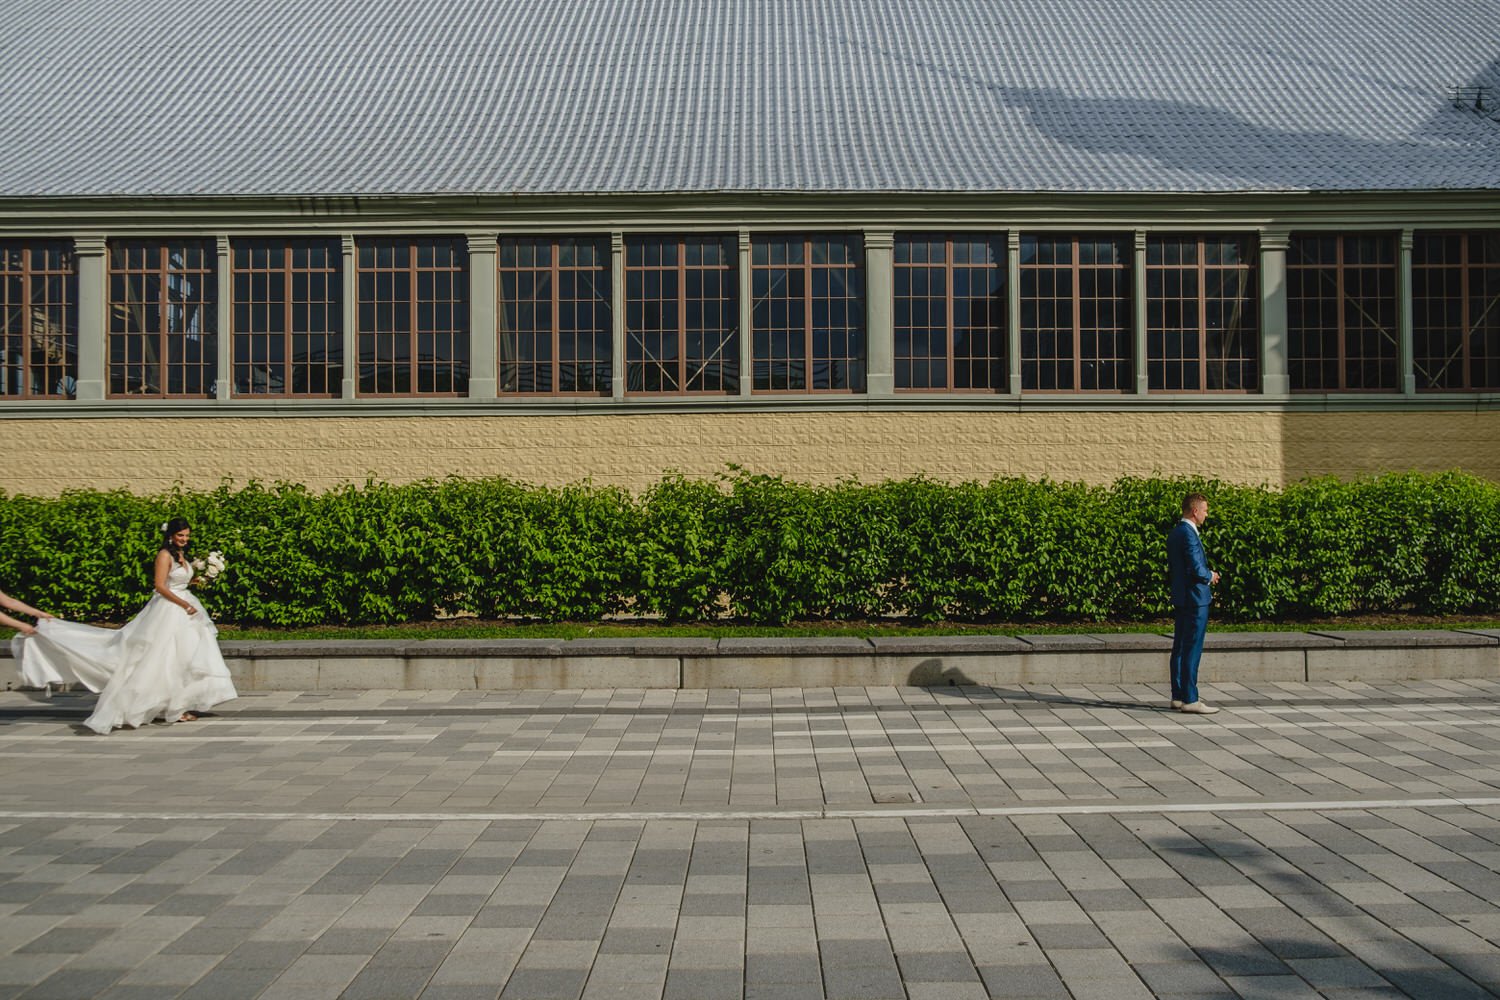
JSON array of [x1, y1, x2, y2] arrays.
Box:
[[894, 234, 1007, 391]]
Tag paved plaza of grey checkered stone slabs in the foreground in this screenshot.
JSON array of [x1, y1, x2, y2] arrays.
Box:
[[0, 677, 1500, 1000]]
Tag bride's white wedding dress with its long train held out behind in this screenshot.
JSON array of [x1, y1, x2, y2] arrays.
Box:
[[12, 564, 239, 733]]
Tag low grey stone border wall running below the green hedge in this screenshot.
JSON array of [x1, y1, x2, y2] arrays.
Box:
[[11, 630, 1500, 691]]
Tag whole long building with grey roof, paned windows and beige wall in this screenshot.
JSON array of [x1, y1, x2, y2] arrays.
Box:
[[0, 0, 1500, 495]]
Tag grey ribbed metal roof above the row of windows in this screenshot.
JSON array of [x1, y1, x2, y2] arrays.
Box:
[[0, 0, 1500, 196]]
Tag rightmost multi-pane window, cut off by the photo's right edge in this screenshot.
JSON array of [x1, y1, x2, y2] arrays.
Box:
[[1412, 232, 1500, 391]]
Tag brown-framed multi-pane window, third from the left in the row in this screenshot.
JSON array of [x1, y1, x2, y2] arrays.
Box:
[[231, 240, 344, 396]]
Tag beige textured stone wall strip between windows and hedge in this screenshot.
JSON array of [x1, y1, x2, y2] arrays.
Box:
[[0, 411, 1500, 496]]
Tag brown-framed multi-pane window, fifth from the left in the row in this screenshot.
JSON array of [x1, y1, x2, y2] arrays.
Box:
[[500, 237, 612, 394]]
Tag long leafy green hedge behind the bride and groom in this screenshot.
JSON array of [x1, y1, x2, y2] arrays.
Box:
[[0, 472, 1500, 625]]
